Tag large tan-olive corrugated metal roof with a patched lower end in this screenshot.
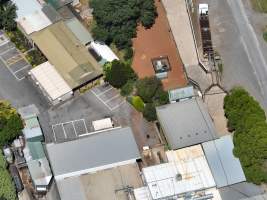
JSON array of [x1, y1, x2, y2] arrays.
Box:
[[31, 21, 102, 89]]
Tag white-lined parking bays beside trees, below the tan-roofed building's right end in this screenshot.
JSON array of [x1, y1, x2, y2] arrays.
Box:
[[91, 84, 125, 111]]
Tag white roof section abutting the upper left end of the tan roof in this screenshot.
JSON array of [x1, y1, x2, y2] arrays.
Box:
[[18, 10, 52, 35]]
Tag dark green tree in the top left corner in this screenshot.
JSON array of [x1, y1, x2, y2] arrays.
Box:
[[0, 0, 17, 31]]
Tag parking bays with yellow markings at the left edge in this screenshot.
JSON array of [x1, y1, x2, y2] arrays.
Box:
[[0, 33, 32, 81]]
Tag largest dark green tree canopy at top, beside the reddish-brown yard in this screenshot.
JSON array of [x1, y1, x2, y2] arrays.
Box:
[[90, 0, 157, 49]]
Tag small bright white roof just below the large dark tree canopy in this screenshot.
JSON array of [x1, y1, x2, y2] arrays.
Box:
[[90, 42, 119, 62]]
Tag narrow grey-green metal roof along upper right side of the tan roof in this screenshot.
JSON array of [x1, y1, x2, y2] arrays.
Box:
[[65, 17, 93, 45]]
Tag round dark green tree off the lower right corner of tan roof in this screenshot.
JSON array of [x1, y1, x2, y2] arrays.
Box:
[[104, 60, 136, 88]]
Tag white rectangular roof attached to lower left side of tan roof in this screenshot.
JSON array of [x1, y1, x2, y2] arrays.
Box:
[[31, 61, 71, 100]]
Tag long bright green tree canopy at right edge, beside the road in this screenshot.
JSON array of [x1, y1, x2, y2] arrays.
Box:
[[224, 88, 267, 184]]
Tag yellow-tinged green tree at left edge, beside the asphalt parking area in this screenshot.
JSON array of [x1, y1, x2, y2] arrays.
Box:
[[0, 101, 23, 146]]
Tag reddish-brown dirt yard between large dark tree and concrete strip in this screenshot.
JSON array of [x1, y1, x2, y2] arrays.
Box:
[[133, 1, 186, 90]]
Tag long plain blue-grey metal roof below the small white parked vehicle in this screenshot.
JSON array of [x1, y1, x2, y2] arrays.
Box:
[[46, 127, 140, 176]]
